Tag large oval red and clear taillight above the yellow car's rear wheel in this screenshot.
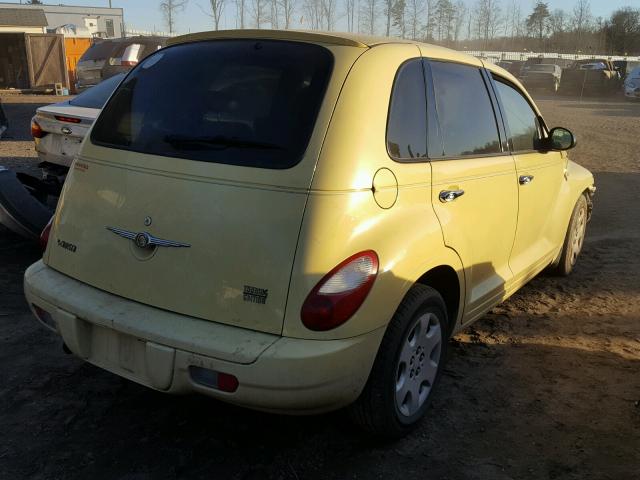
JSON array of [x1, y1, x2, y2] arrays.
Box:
[[300, 250, 378, 331]]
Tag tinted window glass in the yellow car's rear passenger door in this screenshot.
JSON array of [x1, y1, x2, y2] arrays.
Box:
[[431, 62, 501, 157]]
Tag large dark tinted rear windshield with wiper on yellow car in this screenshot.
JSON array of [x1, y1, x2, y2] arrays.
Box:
[[91, 40, 333, 168]]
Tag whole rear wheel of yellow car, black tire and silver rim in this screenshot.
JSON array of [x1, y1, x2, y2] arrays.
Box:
[[350, 285, 449, 438]]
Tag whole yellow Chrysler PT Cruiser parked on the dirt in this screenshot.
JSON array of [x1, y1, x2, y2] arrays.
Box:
[[25, 30, 595, 435]]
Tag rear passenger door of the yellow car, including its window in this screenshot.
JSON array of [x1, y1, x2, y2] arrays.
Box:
[[427, 60, 518, 322]]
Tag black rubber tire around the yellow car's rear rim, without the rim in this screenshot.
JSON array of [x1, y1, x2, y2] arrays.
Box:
[[349, 285, 449, 438]]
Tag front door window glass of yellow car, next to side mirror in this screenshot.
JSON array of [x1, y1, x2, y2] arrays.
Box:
[[495, 80, 539, 152]]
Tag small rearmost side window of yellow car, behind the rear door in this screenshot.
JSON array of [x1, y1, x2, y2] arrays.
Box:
[[387, 59, 427, 160]]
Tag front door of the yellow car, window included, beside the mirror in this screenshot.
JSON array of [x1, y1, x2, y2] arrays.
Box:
[[493, 76, 566, 282]]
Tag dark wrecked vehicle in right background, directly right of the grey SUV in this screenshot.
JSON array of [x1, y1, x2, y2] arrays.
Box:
[[560, 58, 621, 95]]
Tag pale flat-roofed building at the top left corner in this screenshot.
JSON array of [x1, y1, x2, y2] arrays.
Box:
[[0, 2, 125, 38]]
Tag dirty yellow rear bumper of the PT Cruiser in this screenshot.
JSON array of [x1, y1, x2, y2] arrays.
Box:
[[24, 261, 384, 414]]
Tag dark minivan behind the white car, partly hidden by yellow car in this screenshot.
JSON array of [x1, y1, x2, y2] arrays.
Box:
[[76, 37, 167, 92]]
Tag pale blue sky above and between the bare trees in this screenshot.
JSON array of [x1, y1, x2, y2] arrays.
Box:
[[2, 0, 640, 33]]
